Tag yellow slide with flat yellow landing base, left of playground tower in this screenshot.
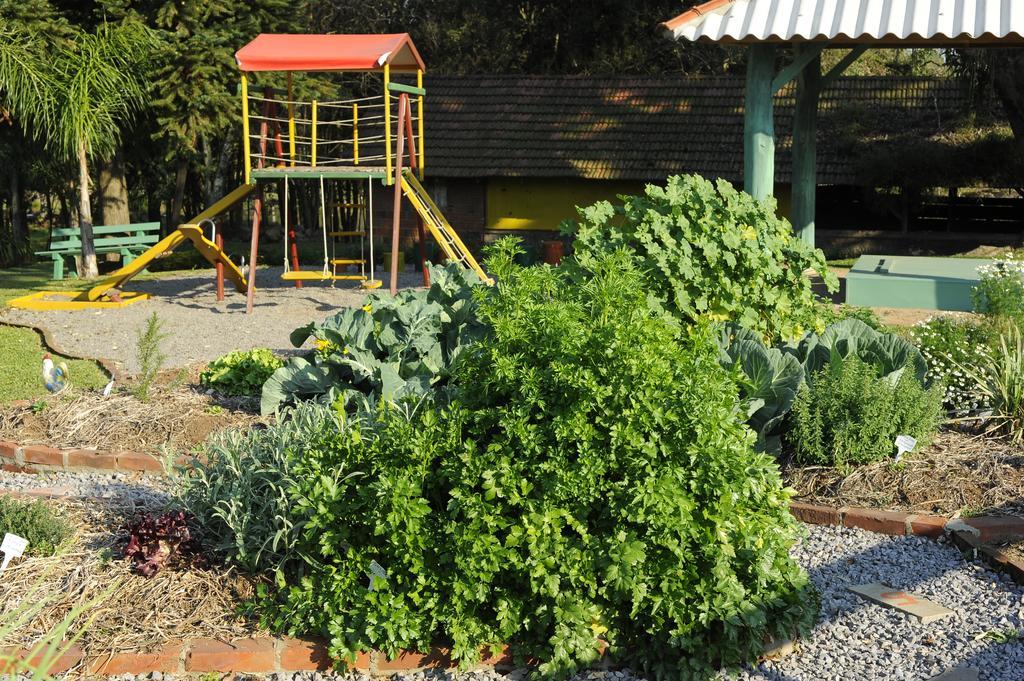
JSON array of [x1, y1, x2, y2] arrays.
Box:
[[8, 184, 256, 310]]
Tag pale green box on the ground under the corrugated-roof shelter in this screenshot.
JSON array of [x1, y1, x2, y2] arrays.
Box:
[[846, 255, 992, 311]]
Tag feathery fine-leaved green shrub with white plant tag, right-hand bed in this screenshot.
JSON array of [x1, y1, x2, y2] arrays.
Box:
[[783, 356, 942, 468]]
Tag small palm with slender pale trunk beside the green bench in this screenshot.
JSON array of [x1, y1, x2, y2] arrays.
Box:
[[51, 20, 155, 278]]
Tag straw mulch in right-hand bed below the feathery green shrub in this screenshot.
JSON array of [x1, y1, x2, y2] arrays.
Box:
[[783, 431, 1024, 515]]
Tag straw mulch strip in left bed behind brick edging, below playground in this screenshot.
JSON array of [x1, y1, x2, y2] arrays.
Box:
[[0, 383, 263, 454]]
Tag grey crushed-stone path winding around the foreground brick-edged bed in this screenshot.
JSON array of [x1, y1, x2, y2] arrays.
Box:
[[0, 473, 1024, 681]]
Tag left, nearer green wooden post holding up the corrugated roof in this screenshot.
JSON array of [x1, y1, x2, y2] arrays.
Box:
[[743, 44, 775, 199]]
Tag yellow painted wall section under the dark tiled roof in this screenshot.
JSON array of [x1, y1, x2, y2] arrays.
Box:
[[487, 178, 644, 230]]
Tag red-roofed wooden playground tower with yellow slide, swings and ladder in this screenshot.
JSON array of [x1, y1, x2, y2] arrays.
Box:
[[10, 34, 490, 312]]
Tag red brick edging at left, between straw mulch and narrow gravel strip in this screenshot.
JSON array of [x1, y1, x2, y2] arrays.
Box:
[[0, 440, 186, 473]]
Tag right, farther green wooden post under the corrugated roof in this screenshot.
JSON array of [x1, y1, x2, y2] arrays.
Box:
[[791, 48, 821, 246]]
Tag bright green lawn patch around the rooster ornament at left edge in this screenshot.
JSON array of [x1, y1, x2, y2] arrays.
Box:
[[0, 325, 110, 403]]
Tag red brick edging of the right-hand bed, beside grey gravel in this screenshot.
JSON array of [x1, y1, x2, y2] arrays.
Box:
[[790, 502, 1024, 584]]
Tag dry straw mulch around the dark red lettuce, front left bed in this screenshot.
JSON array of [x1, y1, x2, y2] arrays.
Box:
[[0, 493, 257, 656]]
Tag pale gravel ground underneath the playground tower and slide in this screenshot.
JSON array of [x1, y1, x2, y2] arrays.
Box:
[[0, 267, 423, 374]]
